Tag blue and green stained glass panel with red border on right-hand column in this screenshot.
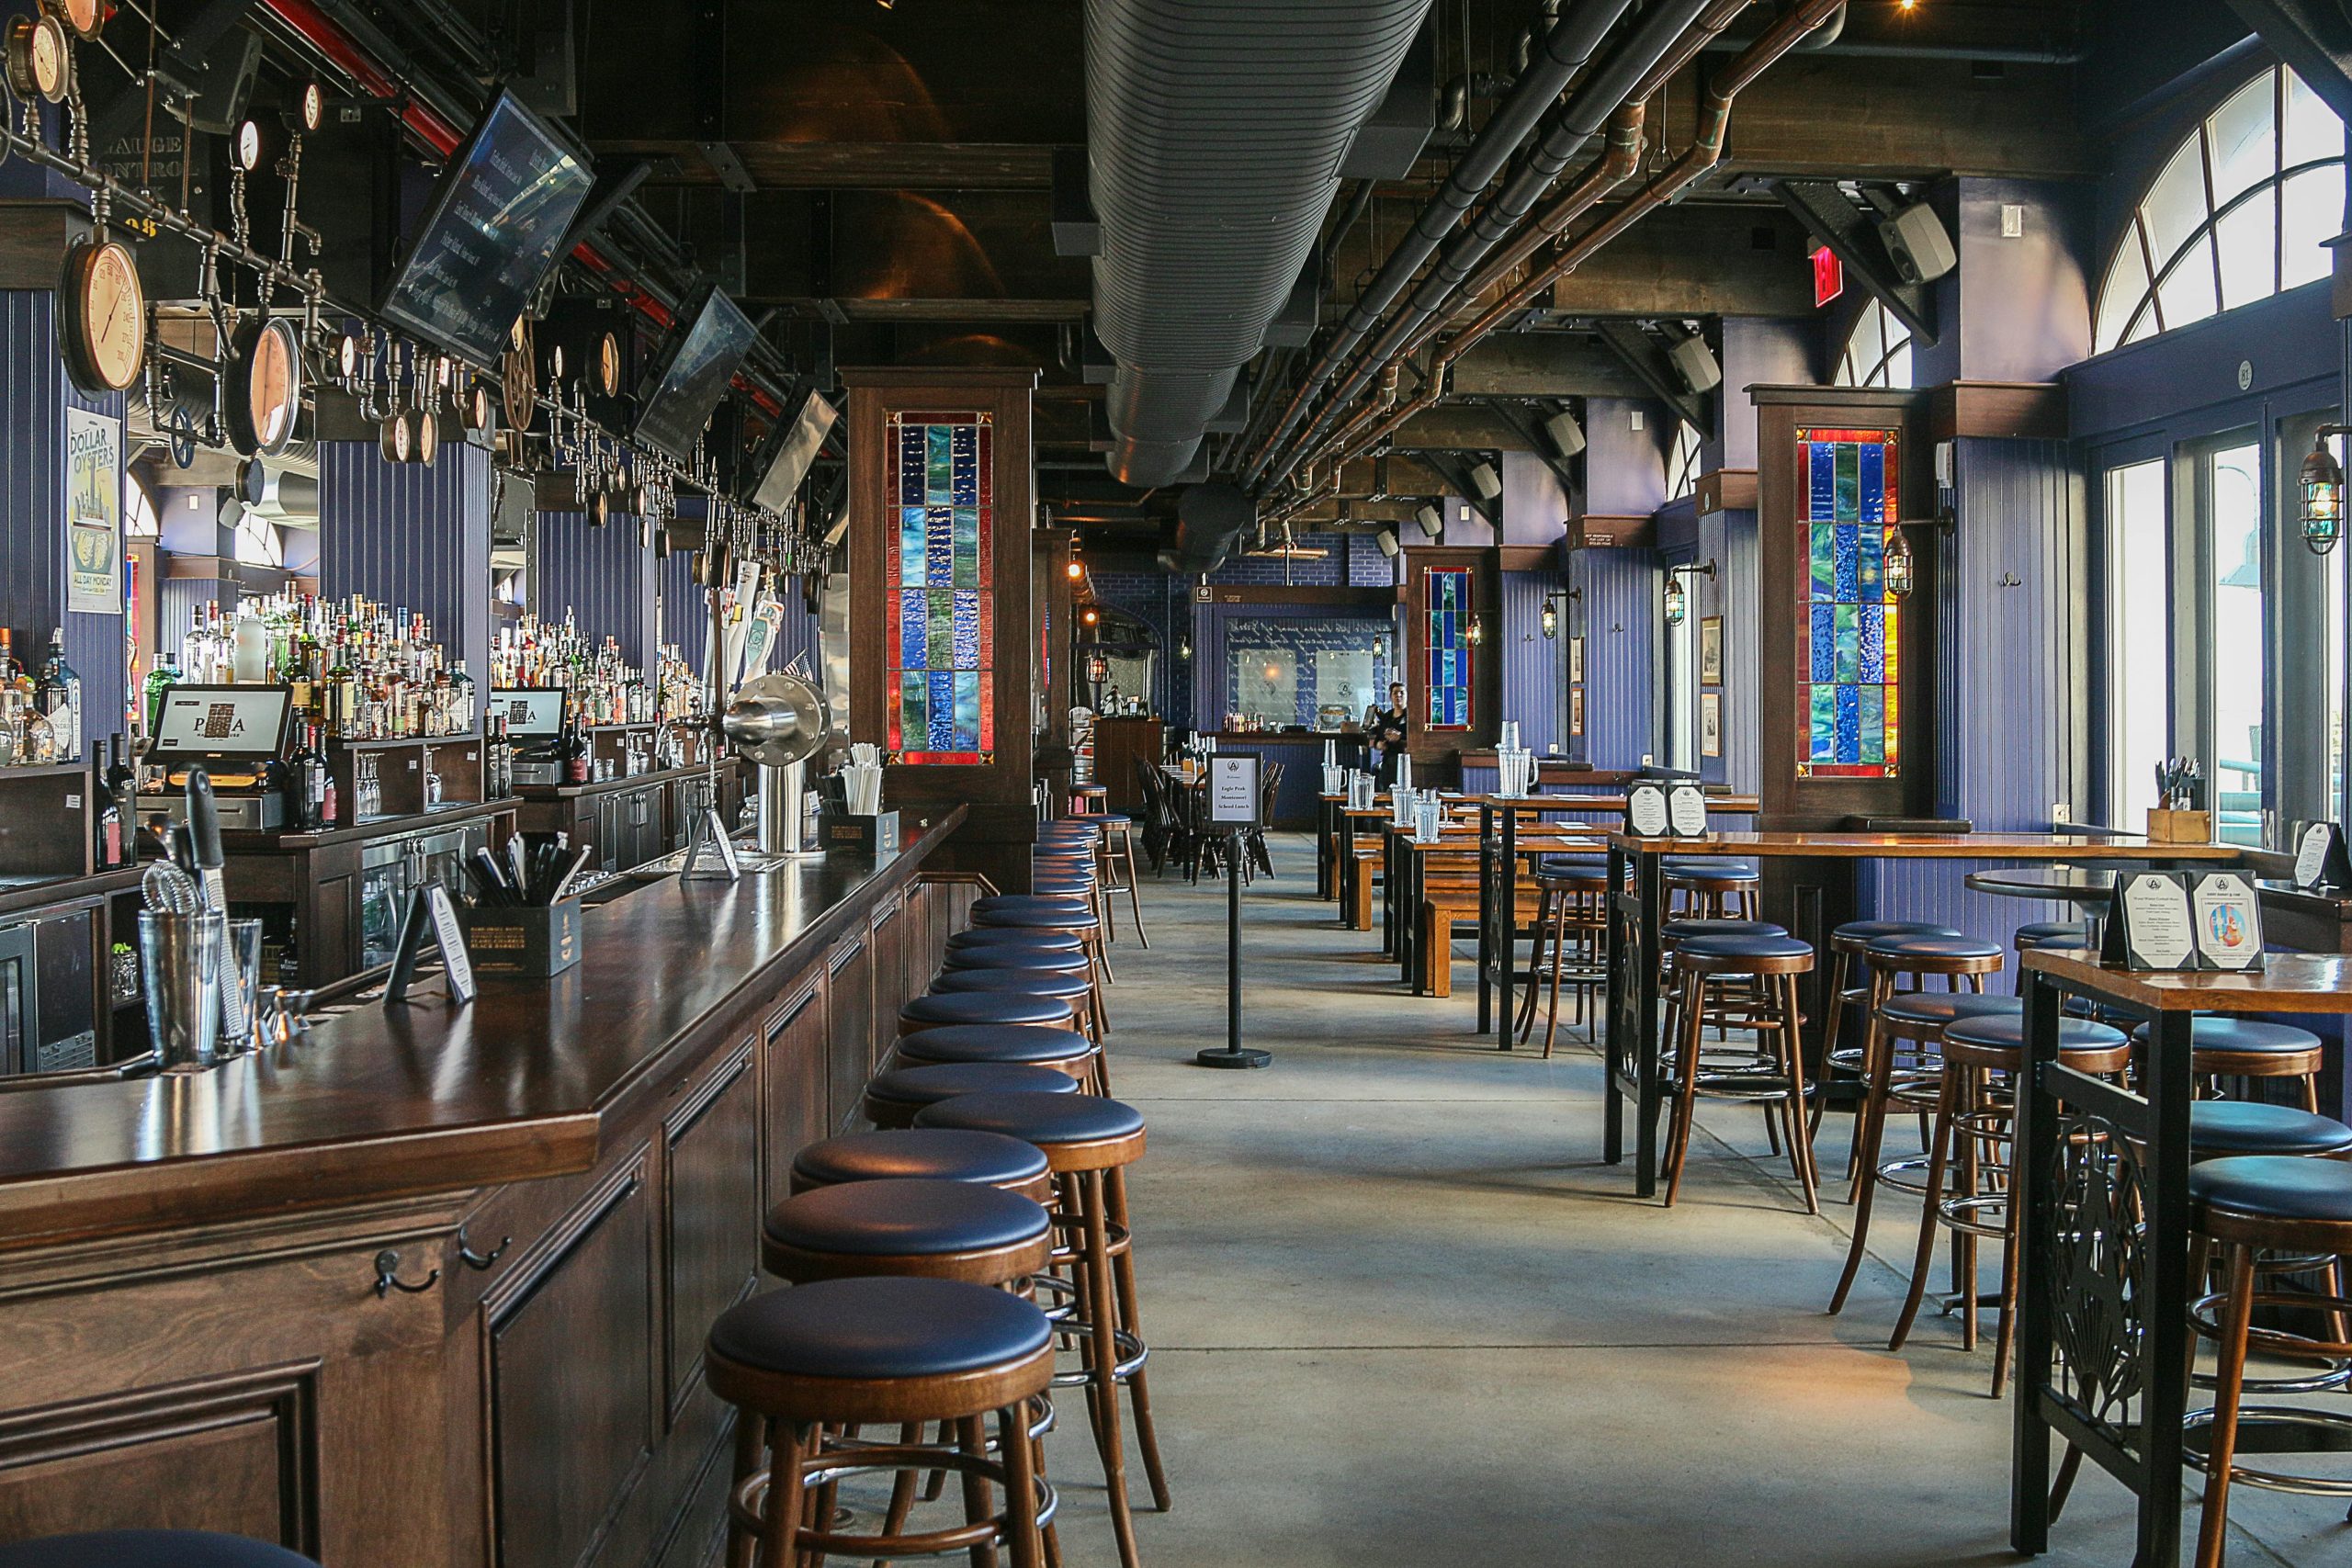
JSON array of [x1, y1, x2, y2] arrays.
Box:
[[1797, 430, 1900, 778]]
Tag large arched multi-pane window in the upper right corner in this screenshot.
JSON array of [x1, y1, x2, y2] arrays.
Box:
[[2091, 66, 2345, 353]]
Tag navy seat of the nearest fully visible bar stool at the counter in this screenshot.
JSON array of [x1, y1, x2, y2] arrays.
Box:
[[710, 1279, 1054, 1378]]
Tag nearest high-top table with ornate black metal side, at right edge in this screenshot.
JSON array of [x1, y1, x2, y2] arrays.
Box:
[[2008, 944, 2352, 1568]]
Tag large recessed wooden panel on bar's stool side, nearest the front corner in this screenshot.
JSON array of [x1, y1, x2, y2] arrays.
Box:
[[489, 1159, 659, 1568]]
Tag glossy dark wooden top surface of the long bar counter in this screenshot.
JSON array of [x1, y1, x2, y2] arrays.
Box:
[[0, 807, 965, 1246]]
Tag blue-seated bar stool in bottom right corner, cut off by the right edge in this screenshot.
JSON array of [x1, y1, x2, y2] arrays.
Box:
[[2188, 1155, 2352, 1568]]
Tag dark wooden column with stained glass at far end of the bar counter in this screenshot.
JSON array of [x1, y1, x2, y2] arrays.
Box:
[[842, 367, 1045, 888]]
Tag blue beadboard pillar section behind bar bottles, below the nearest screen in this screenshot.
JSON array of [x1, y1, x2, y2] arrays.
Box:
[[318, 442, 492, 680]]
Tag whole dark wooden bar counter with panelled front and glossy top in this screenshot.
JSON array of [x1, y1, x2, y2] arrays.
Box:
[[0, 807, 976, 1568]]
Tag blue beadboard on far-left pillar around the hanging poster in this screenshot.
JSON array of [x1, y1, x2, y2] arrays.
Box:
[[0, 289, 127, 755]]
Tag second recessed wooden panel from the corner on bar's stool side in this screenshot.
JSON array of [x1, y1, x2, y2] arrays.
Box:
[[663, 1042, 760, 1411]]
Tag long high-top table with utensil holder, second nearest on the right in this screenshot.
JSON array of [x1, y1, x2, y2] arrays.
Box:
[[1599, 832, 2244, 1197]]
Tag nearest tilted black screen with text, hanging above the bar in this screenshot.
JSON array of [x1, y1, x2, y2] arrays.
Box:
[[381, 94, 595, 367]]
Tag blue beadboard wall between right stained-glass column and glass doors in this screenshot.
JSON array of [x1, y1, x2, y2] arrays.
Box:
[[1860, 440, 2086, 945]]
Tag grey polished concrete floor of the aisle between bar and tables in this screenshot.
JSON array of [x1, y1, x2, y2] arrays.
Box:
[[1051, 840, 2352, 1568]]
